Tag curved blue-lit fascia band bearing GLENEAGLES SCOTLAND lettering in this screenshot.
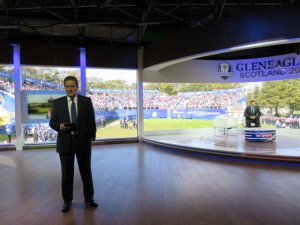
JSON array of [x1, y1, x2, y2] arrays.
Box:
[[142, 53, 300, 83]]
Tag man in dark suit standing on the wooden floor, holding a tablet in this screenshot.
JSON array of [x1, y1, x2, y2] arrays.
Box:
[[50, 76, 98, 212]]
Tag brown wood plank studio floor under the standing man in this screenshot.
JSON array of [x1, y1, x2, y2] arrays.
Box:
[[0, 143, 300, 225]]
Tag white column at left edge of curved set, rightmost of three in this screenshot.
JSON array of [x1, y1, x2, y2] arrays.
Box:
[[137, 48, 144, 141]]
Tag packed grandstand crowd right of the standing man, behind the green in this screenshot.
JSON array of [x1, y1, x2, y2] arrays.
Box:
[[88, 91, 246, 111]]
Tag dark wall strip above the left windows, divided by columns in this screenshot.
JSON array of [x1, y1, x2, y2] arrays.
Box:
[[0, 40, 137, 69]]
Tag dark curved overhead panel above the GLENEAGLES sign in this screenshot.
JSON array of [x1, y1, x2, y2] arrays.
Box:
[[144, 4, 300, 67]]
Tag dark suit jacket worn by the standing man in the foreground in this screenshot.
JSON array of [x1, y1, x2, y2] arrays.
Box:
[[49, 95, 96, 153]]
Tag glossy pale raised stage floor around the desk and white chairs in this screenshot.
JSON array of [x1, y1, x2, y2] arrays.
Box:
[[146, 128, 300, 160]]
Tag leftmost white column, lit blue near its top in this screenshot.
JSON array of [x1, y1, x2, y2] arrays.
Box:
[[13, 44, 24, 150]]
